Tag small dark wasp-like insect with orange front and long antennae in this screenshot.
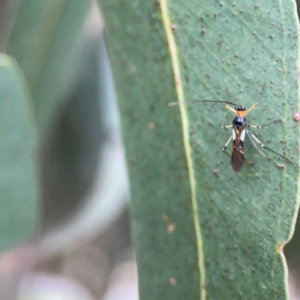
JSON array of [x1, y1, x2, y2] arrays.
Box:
[[169, 100, 292, 172]]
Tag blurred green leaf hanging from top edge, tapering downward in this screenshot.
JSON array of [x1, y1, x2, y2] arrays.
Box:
[[7, 0, 91, 136]]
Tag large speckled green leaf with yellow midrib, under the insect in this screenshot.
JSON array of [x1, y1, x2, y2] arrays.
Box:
[[99, 0, 299, 300]]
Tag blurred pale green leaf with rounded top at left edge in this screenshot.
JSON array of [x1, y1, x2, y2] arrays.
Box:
[[0, 54, 39, 251]]
